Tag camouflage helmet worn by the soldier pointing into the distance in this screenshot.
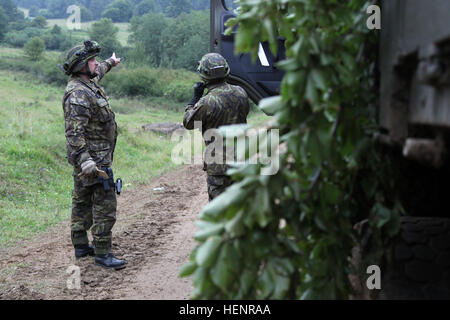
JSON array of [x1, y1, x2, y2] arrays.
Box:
[[60, 40, 102, 75]]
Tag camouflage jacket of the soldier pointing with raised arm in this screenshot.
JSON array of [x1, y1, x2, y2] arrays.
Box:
[[62, 59, 117, 182]]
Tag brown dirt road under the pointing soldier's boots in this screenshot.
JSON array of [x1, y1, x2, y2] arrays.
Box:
[[0, 165, 208, 300]]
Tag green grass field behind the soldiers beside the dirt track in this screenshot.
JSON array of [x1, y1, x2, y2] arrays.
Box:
[[0, 65, 267, 247]]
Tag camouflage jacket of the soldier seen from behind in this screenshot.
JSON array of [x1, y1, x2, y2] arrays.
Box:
[[183, 82, 250, 175]]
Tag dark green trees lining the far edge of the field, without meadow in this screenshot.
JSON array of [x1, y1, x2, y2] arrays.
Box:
[[0, 0, 209, 70]]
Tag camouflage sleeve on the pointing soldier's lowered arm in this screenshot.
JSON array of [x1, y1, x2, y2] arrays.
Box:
[[65, 91, 91, 165]]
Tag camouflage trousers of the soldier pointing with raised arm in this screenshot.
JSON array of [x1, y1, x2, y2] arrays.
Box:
[[71, 176, 117, 254]]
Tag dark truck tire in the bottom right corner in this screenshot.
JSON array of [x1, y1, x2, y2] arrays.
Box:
[[378, 217, 450, 300]]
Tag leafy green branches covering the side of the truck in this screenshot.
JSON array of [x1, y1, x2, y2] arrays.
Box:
[[181, 0, 400, 299]]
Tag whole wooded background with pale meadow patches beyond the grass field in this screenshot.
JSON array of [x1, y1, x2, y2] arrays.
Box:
[[0, 0, 213, 71]]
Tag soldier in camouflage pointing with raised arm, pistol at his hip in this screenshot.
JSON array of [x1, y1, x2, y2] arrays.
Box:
[[60, 41, 125, 269]]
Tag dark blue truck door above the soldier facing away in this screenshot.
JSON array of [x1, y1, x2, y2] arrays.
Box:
[[210, 0, 285, 103]]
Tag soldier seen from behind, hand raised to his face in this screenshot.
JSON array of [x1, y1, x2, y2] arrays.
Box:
[[183, 53, 250, 201]]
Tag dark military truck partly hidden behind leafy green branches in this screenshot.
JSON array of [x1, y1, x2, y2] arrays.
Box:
[[210, 0, 450, 299]]
